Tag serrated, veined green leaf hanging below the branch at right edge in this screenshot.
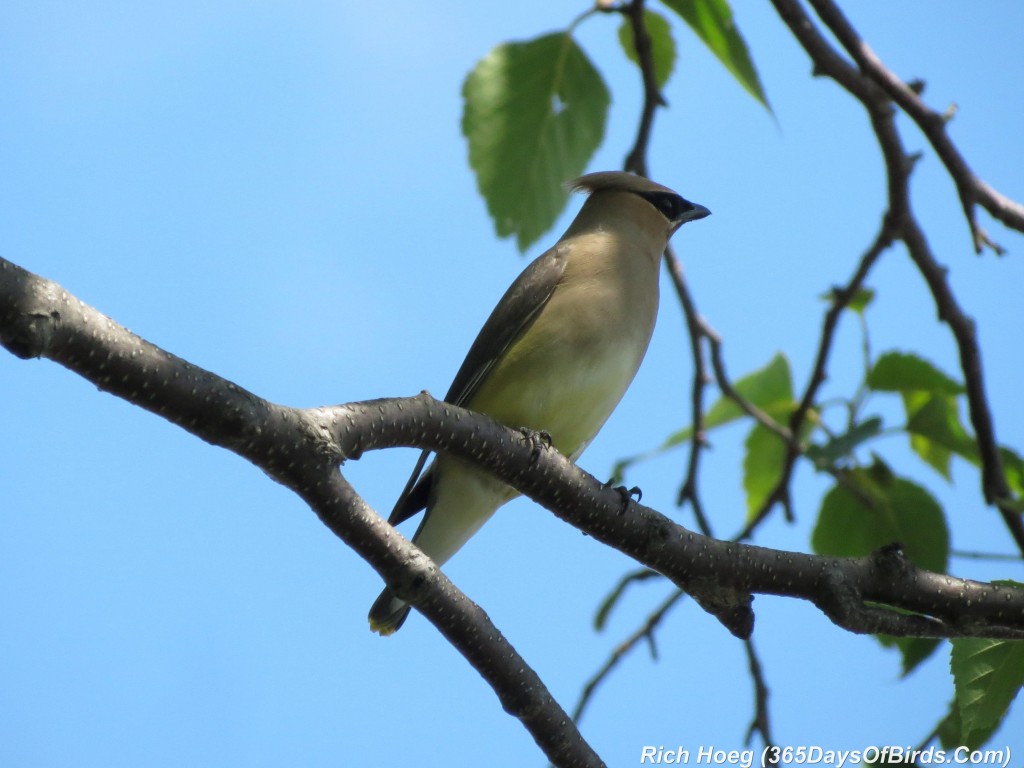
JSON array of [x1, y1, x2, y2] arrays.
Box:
[[949, 638, 1024, 748]]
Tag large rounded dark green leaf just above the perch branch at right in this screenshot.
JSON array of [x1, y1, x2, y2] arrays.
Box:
[[811, 468, 949, 572]]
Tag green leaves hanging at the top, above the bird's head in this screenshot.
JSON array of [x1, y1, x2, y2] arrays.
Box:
[[462, 0, 770, 251]]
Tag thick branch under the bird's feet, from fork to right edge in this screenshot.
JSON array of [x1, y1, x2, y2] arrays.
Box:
[[327, 394, 1024, 637]]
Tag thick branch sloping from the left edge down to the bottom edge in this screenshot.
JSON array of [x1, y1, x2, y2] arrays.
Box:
[[0, 259, 604, 768]]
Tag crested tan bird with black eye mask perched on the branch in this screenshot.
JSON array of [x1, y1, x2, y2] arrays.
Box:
[[369, 171, 711, 635]]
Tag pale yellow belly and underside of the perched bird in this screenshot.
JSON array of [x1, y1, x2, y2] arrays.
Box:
[[415, 252, 657, 563]]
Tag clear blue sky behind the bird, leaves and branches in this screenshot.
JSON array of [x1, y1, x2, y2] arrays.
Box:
[[0, 0, 1024, 767]]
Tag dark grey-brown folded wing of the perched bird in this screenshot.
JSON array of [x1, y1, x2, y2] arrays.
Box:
[[388, 244, 569, 525]]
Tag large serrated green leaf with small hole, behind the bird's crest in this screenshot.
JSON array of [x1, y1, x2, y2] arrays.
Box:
[[462, 33, 610, 251]]
